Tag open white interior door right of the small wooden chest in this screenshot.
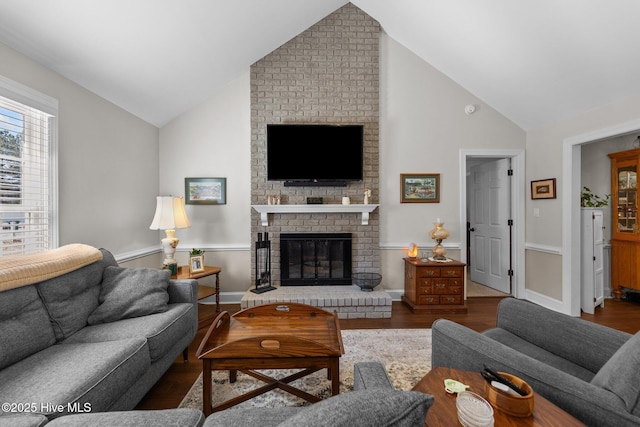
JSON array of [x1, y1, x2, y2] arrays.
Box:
[[469, 159, 511, 294]]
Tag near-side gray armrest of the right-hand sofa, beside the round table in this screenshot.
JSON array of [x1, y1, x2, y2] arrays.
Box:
[[431, 319, 640, 426]]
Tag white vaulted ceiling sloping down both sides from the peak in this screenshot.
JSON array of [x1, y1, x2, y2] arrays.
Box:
[[0, 0, 640, 130]]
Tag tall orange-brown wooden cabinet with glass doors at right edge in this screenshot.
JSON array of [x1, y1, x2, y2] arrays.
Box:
[[609, 149, 640, 299]]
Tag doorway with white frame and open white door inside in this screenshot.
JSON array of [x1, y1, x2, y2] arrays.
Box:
[[460, 150, 525, 298]]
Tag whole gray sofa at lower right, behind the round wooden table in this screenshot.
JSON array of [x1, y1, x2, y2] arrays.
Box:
[[432, 298, 640, 427]]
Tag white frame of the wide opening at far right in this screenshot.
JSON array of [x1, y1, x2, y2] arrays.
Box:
[[556, 119, 640, 316]]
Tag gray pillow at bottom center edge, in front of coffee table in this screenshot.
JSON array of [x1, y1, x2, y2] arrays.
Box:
[[279, 388, 433, 427]]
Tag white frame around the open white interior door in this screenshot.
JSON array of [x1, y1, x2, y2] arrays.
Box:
[[460, 149, 526, 298]]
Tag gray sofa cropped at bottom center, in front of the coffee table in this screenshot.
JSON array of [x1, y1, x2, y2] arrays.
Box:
[[204, 362, 433, 427]]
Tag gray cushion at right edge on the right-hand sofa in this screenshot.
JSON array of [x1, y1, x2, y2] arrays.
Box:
[[591, 332, 640, 415]]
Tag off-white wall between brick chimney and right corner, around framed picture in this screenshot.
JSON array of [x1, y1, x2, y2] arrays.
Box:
[[380, 35, 525, 289]]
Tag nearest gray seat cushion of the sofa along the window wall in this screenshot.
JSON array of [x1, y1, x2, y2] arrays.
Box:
[[0, 338, 150, 418]]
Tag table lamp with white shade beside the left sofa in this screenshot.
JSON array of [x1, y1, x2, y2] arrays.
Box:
[[149, 196, 191, 276]]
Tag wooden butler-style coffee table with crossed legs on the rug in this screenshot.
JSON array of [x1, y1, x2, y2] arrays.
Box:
[[196, 303, 344, 415]]
